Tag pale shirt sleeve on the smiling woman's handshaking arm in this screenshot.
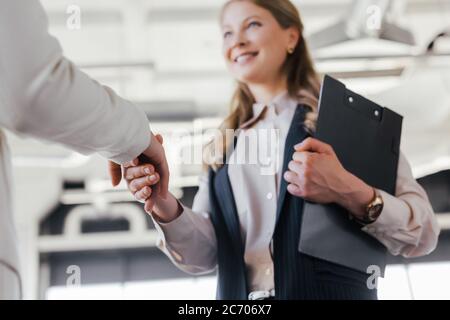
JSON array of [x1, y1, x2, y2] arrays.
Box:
[[152, 174, 217, 274]]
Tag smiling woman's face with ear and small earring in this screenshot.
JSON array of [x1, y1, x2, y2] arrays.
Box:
[[221, 1, 299, 84]]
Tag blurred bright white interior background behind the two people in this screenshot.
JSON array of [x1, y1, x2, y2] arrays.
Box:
[[9, 0, 450, 299]]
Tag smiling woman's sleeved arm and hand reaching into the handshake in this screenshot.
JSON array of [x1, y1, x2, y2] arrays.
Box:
[[125, 160, 217, 274]]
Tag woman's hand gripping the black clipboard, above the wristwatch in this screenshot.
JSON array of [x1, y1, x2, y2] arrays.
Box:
[[284, 138, 374, 215]]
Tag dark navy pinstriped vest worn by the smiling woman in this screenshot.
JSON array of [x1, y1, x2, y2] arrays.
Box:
[[209, 105, 377, 300]]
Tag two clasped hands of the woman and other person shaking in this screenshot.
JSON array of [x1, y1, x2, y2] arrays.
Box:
[[109, 134, 182, 222]]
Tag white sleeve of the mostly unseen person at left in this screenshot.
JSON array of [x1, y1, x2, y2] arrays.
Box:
[[0, 0, 150, 163]]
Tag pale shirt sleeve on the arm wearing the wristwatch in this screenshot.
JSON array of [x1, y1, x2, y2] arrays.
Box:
[[362, 154, 440, 257]]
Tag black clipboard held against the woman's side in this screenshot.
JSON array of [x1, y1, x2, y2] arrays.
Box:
[[299, 76, 403, 275]]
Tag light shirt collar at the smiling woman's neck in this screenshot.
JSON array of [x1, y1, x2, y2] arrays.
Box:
[[239, 90, 298, 129]]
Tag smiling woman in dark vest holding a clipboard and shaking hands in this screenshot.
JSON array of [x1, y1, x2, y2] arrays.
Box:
[[126, 0, 439, 299]]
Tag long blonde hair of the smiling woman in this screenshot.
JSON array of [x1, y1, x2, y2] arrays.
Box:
[[203, 0, 320, 170]]
